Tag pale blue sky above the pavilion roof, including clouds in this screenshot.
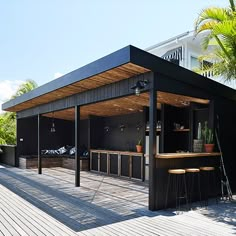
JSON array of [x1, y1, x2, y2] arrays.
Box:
[[0, 0, 228, 105]]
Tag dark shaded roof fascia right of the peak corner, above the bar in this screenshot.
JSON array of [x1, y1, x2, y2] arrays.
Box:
[[130, 47, 236, 101]]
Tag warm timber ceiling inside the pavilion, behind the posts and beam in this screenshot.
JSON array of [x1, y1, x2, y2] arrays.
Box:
[[44, 91, 209, 120]]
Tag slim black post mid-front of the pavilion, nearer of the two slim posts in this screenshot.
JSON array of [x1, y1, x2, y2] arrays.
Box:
[[75, 106, 80, 187]]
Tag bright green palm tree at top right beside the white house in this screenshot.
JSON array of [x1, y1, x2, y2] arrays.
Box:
[[195, 0, 236, 80]]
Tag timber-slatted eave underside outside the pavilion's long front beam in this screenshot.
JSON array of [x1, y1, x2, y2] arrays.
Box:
[[8, 63, 149, 112]]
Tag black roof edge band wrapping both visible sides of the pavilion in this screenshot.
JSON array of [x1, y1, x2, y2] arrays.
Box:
[[2, 45, 236, 110]]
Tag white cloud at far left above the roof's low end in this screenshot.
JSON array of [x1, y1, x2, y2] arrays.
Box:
[[0, 80, 24, 112]]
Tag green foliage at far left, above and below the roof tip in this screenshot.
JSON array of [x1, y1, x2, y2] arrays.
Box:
[[0, 80, 37, 144]]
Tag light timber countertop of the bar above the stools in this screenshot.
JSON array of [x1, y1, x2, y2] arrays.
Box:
[[156, 152, 221, 159]]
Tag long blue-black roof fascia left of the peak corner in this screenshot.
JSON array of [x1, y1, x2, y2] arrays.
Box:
[[2, 45, 132, 110]]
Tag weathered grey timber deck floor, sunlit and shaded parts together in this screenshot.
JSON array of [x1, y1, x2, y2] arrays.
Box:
[[0, 165, 236, 236]]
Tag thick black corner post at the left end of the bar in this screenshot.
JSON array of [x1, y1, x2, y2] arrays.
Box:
[[148, 74, 158, 211]]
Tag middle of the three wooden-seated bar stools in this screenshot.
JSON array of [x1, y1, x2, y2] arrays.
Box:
[[185, 168, 202, 207]]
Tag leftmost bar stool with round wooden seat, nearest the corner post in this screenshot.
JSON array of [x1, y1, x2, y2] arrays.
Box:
[[165, 169, 188, 210]]
